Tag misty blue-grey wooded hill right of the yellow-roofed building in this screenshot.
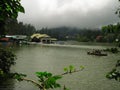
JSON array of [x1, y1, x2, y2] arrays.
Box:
[[37, 27, 101, 42]]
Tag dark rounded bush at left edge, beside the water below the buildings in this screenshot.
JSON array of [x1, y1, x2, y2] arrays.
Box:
[[0, 48, 16, 73]]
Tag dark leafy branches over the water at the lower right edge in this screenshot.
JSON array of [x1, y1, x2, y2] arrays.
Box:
[[106, 60, 120, 81]]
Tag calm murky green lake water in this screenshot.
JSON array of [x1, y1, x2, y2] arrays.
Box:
[[0, 45, 120, 90]]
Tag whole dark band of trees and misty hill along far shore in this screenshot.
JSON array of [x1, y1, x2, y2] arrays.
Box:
[[5, 19, 120, 43]]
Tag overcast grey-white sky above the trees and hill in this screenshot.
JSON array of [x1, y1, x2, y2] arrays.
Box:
[[18, 0, 119, 29]]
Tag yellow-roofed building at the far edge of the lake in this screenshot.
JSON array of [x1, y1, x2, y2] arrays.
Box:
[[31, 34, 57, 44]]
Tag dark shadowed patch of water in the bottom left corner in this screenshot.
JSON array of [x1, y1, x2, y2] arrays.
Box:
[[0, 79, 15, 90]]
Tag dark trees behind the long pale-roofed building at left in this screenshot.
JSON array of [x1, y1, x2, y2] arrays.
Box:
[[6, 19, 36, 36]]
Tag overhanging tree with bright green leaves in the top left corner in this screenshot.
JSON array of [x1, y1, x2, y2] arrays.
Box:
[[0, 0, 25, 35]]
